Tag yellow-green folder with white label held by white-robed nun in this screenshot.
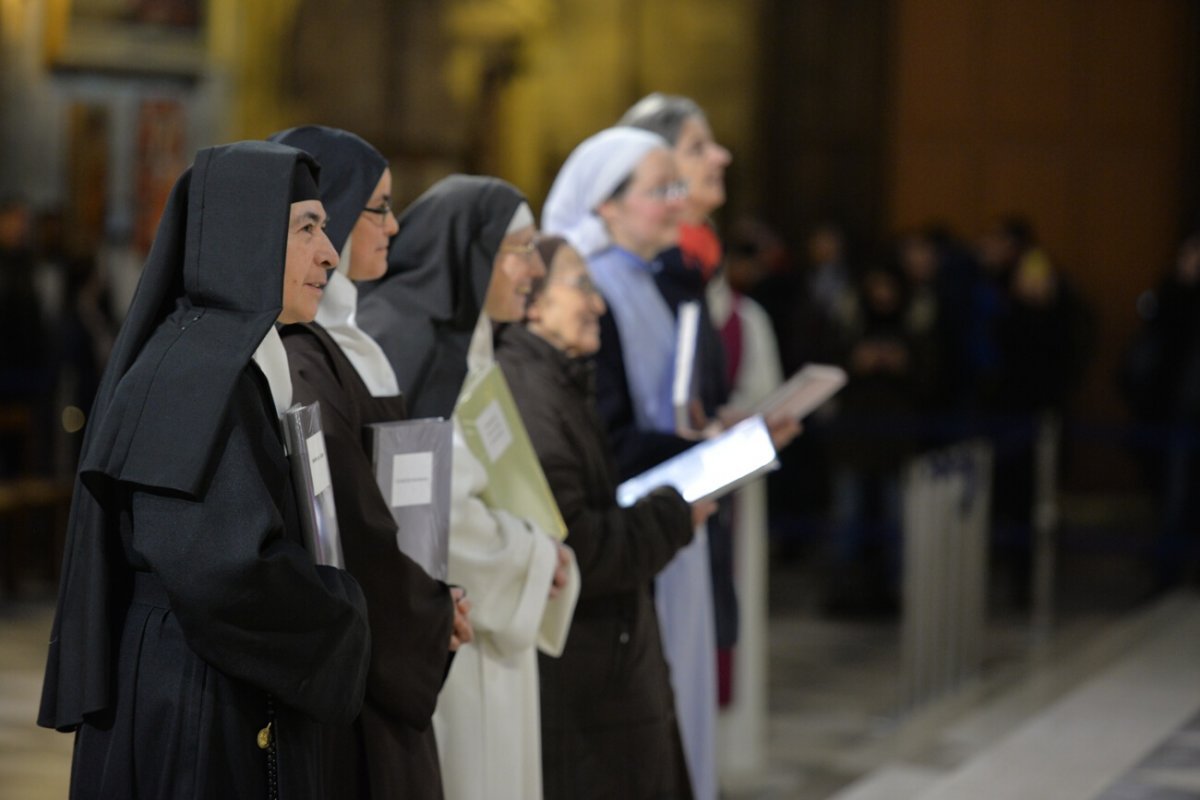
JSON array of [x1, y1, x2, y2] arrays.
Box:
[[454, 363, 566, 541]]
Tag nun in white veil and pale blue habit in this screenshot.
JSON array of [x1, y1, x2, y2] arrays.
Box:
[[542, 127, 716, 800]]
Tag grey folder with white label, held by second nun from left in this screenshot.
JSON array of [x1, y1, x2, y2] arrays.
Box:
[[367, 417, 454, 582]]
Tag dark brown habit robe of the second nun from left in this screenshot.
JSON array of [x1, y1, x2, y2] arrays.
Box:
[[282, 323, 454, 799]]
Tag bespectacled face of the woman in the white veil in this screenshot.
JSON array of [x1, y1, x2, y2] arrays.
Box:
[[598, 148, 686, 260]]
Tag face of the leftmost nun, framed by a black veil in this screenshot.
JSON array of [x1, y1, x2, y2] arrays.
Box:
[[280, 200, 337, 325]]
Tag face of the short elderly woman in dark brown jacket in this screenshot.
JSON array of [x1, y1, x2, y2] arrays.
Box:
[[529, 245, 605, 357]]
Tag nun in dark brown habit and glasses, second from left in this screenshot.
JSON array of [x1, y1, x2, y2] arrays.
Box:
[[271, 126, 470, 800]]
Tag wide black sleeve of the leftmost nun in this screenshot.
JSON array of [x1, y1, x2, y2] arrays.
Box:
[[131, 373, 370, 723]]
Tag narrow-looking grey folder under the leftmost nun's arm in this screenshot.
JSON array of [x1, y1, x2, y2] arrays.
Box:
[[283, 402, 346, 569]]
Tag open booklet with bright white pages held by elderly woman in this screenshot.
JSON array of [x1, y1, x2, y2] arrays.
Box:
[[617, 416, 779, 507]]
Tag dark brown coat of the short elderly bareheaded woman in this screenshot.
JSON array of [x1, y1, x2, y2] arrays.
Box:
[[496, 325, 692, 799]]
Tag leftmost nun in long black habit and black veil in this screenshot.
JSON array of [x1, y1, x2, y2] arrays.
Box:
[[38, 143, 370, 799]]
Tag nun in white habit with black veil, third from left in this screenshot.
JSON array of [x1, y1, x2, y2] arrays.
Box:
[[359, 175, 580, 800]]
